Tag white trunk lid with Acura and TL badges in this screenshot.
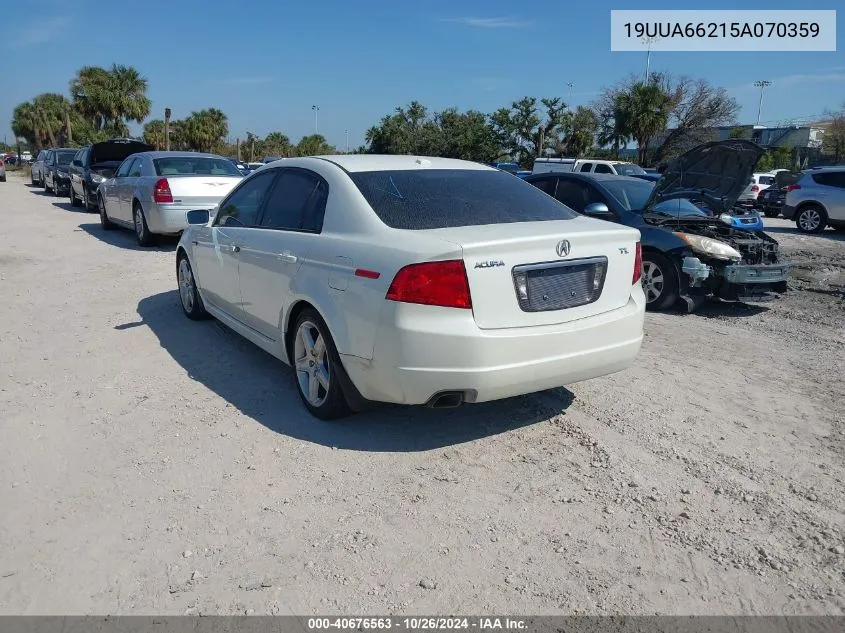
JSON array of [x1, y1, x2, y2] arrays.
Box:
[[425, 217, 639, 329]]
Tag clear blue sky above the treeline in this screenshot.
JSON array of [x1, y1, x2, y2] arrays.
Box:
[[0, 0, 845, 149]]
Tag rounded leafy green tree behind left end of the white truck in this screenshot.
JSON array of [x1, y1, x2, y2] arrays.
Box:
[[490, 97, 570, 167]]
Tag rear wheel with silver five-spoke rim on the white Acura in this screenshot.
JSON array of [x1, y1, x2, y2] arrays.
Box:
[[291, 308, 352, 420]]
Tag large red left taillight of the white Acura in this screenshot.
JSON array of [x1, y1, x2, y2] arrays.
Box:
[[385, 259, 472, 309]]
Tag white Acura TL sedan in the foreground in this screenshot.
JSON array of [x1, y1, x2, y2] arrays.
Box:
[[176, 155, 645, 419]]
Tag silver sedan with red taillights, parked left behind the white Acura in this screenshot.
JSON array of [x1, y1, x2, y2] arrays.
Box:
[[97, 152, 243, 246]]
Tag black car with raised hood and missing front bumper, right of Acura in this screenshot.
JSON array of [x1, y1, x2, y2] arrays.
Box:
[[525, 139, 789, 312]]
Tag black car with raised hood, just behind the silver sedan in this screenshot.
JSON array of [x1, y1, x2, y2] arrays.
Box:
[[68, 138, 155, 211]]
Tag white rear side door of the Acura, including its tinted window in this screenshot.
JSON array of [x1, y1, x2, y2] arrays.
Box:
[[238, 168, 328, 340]]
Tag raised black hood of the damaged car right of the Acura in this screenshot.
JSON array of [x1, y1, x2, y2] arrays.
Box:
[[645, 139, 765, 214]]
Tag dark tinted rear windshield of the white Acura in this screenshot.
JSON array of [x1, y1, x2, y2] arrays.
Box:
[[350, 169, 578, 230]]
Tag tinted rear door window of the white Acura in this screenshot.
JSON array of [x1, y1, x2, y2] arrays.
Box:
[[259, 169, 328, 231]]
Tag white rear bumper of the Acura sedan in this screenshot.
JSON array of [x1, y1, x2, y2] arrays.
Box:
[[342, 286, 645, 405]]
